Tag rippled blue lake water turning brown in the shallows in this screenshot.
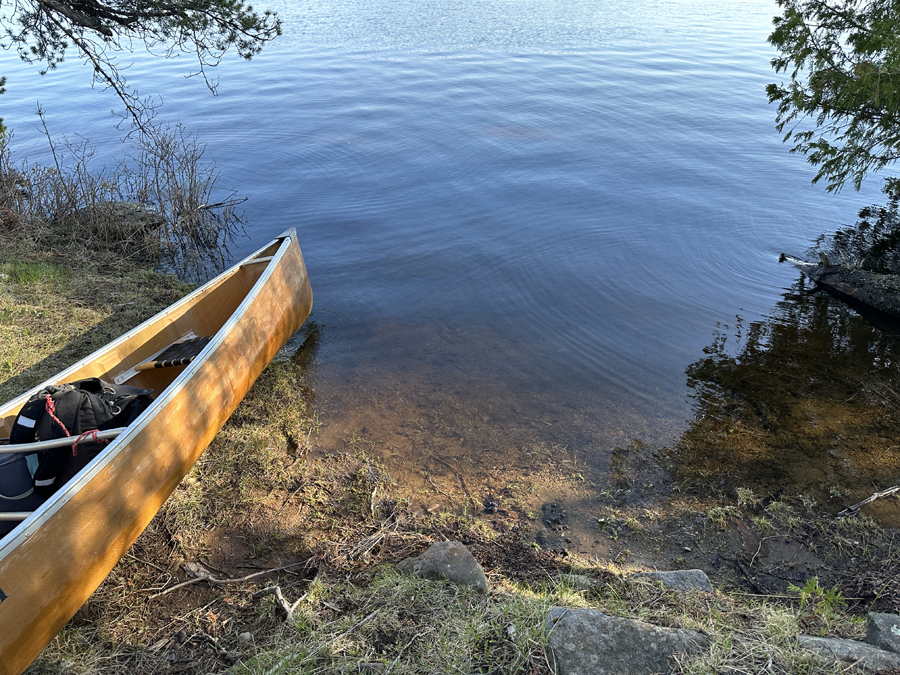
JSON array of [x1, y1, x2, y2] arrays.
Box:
[[0, 0, 892, 544]]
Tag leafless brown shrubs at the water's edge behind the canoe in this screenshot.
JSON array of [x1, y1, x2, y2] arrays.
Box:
[[0, 117, 246, 280]]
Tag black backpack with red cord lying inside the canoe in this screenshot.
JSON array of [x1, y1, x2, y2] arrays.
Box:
[[6, 377, 153, 502]]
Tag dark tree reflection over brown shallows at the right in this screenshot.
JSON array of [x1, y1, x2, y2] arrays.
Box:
[[674, 279, 900, 520]]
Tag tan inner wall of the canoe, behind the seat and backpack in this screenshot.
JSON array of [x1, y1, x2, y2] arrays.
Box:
[[0, 242, 279, 438]]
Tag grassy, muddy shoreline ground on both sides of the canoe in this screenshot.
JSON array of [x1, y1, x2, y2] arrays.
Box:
[[0, 235, 900, 674]]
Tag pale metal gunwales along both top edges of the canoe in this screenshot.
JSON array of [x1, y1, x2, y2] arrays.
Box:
[[0, 229, 297, 562]]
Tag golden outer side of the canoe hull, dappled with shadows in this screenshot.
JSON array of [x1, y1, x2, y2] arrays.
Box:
[[0, 230, 312, 675]]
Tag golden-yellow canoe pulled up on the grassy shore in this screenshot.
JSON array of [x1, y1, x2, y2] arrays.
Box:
[[0, 229, 312, 675]]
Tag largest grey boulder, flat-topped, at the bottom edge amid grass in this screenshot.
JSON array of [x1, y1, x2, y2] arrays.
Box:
[[547, 607, 709, 675]]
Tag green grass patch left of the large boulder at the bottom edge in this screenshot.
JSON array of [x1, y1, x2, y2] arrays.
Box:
[[235, 567, 552, 675]]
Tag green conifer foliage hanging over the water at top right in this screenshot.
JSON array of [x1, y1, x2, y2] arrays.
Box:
[[767, 0, 900, 191]]
